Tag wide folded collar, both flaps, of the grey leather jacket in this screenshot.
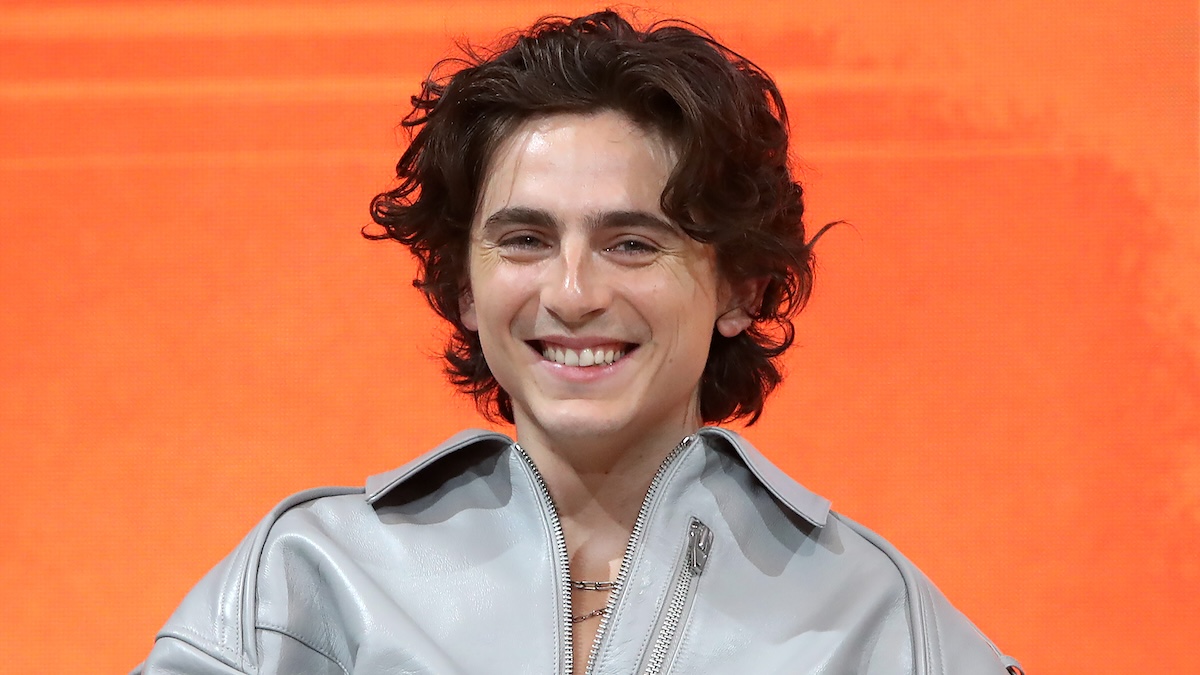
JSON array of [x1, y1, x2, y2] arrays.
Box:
[[366, 426, 829, 527]]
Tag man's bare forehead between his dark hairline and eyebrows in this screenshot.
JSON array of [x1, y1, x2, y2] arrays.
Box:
[[475, 110, 677, 222]]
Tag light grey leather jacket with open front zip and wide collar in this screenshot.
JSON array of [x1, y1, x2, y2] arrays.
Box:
[[134, 428, 1016, 675]]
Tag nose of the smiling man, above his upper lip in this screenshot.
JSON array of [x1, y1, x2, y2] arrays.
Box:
[[541, 238, 612, 325]]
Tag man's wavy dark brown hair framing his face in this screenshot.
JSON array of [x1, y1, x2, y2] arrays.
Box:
[[364, 11, 820, 424]]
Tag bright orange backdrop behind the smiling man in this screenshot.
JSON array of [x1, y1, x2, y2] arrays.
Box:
[[0, 0, 1200, 674]]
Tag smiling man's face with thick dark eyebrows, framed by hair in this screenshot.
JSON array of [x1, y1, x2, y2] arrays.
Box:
[[462, 112, 745, 444]]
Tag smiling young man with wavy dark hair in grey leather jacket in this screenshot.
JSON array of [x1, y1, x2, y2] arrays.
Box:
[[143, 12, 1015, 674]]
